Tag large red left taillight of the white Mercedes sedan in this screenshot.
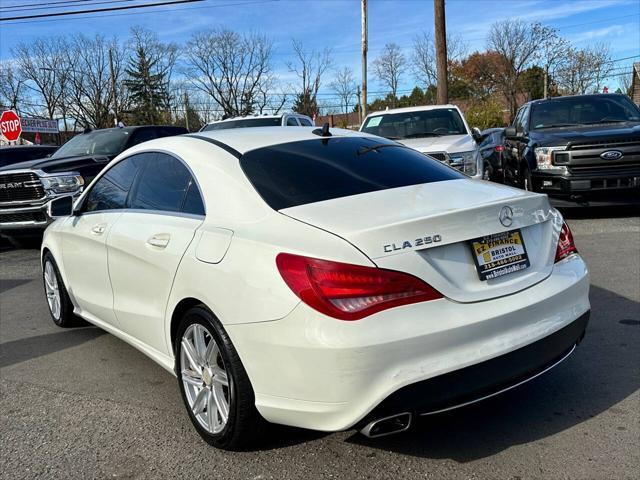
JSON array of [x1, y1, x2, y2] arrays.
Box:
[[276, 253, 442, 320]]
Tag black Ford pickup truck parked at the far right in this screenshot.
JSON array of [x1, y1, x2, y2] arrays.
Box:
[[504, 94, 640, 205]]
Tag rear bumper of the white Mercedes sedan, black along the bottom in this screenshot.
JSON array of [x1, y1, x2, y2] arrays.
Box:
[[227, 255, 590, 431]]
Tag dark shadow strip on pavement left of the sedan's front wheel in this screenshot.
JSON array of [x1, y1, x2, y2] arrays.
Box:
[[0, 327, 106, 368]]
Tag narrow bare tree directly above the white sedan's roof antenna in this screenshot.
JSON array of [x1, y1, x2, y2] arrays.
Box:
[[287, 40, 332, 116]]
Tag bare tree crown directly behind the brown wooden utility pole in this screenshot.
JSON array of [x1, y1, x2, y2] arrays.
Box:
[[410, 30, 468, 89]]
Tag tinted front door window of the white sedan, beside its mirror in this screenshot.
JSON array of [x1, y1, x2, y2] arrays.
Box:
[[83, 153, 146, 212]]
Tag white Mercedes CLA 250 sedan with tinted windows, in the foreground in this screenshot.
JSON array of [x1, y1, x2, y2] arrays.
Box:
[[42, 126, 590, 449]]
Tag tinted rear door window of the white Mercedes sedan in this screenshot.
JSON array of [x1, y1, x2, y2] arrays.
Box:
[[130, 153, 192, 212]]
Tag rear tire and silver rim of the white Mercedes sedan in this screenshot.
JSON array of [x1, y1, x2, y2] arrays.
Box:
[[175, 305, 266, 450]]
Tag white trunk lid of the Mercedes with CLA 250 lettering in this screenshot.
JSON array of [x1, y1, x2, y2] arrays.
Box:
[[280, 179, 560, 302]]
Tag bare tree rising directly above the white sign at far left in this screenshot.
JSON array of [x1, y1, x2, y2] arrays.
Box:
[[12, 37, 69, 129]]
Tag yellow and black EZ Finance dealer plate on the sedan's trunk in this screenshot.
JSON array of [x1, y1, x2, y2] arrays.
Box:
[[471, 230, 530, 280]]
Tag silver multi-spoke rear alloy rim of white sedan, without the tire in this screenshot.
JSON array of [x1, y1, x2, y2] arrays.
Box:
[[180, 323, 231, 434]]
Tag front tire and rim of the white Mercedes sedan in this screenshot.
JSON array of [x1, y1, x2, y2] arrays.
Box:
[[42, 252, 86, 328]]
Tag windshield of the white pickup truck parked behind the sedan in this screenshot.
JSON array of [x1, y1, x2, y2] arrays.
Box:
[[362, 108, 467, 139]]
